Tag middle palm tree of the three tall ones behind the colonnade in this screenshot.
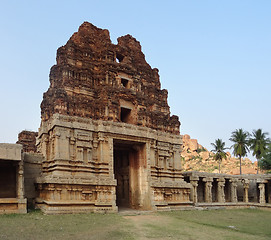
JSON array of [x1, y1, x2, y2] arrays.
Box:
[[230, 128, 249, 175]]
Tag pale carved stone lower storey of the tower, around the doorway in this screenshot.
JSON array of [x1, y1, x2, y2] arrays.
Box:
[[35, 114, 191, 213]]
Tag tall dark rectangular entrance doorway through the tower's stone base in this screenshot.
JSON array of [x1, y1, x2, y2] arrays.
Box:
[[114, 140, 149, 210]]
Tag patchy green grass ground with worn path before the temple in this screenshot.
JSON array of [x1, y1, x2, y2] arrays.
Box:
[[0, 209, 271, 240]]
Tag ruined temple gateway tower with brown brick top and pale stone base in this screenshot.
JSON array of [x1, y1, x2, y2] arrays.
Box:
[[37, 22, 190, 213]]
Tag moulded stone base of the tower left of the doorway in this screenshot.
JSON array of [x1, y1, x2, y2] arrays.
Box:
[[36, 178, 118, 214]]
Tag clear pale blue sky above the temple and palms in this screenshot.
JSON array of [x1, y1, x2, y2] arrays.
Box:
[[0, 0, 271, 161]]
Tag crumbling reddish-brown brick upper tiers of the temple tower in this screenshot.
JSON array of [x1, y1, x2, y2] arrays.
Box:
[[41, 22, 180, 134]]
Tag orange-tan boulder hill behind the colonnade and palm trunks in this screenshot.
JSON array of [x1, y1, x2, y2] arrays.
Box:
[[181, 134, 257, 174]]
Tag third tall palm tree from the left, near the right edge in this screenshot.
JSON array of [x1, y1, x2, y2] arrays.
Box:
[[249, 129, 270, 174]]
